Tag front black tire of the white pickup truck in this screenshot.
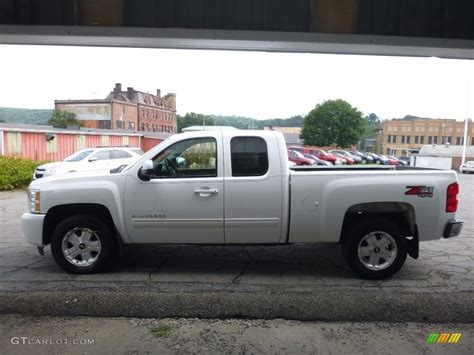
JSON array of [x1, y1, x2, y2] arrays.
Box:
[[51, 214, 116, 274]]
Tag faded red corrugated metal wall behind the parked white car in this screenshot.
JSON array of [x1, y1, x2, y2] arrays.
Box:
[[0, 131, 150, 161]]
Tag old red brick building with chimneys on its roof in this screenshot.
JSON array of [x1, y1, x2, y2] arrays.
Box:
[[54, 83, 176, 133]]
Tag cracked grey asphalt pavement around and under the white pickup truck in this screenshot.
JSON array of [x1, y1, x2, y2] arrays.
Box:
[[0, 175, 474, 324]]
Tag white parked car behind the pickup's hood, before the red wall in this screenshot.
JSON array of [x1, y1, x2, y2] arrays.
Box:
[[33, 147, 143, 179]]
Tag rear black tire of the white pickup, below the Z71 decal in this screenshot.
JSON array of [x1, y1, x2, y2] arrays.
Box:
[[342, 218, 407, 280]]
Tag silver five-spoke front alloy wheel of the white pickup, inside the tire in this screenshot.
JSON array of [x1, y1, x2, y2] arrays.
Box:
[[61, 227, 101, 266]]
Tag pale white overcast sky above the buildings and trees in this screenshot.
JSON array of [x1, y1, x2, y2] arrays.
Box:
[[0, 45, 474, 120]]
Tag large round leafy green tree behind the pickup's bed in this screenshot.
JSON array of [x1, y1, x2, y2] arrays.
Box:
[[300, 99, 367, 148]]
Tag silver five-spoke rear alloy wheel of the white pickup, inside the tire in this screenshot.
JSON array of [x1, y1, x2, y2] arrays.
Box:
[[357, 231, 398, 271]]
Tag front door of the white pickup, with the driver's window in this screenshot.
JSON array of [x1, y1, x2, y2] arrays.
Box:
[[124, 132, 224, 243]]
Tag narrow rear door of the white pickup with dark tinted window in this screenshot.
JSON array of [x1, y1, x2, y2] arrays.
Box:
[[223, 133, 288, 243]]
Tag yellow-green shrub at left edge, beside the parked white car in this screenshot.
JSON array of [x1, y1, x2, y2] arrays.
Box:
[[0, 156, 43, 190]]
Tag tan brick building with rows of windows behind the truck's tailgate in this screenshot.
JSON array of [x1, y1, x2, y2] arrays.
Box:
[[378, 119, 474, 156]]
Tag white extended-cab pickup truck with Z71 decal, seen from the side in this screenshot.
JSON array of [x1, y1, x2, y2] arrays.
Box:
[[22, 130, 462, 279]]
